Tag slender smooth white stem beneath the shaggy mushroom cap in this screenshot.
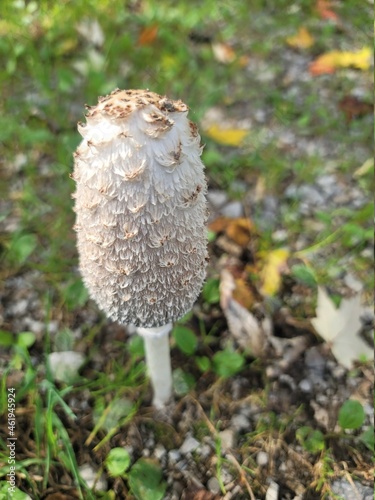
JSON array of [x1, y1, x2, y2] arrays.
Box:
[[137, 323, 172, 408]]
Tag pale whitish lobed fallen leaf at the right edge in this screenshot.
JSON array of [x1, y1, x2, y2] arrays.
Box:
[[311, 287, 374, 369]]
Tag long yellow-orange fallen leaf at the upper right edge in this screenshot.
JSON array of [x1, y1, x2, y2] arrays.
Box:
[[309, 47, 371, 76]]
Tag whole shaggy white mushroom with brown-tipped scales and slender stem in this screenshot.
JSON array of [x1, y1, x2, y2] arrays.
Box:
[[72, 89, 208, 407]]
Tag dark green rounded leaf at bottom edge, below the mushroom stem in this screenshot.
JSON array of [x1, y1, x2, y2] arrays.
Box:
[[129, 458, 166, 500]]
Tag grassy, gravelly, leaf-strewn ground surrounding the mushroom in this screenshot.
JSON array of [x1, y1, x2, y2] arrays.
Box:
[[0, 0, 374, 500]]
